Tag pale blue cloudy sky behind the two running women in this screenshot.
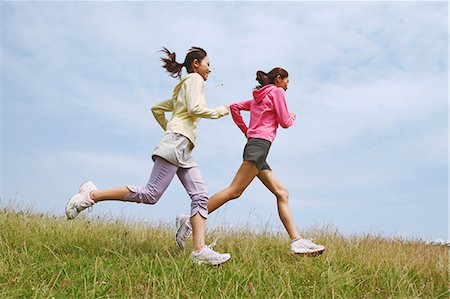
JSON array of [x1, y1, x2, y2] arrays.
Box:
[[0, 1, 449, 240]]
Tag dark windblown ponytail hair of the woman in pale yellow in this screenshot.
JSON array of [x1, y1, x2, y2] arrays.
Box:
[[159, 47, 208, 79]]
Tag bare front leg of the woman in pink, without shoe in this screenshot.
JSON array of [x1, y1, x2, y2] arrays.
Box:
[[258, 170, 300, 240]]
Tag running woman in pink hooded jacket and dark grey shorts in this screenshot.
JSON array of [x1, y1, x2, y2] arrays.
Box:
[[176, 67, 325, 254]]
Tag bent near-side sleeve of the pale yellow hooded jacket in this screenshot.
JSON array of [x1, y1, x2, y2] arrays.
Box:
[[186, 76, 229, 119]]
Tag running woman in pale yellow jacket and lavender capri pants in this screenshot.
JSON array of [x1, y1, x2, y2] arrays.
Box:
[[66, 47, 230, 265]]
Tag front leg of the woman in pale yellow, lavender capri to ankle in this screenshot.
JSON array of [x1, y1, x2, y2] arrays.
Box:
[[177, 167, 209, 250]]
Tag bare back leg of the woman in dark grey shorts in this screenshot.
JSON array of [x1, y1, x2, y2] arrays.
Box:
[[208, 161, 259, 213]]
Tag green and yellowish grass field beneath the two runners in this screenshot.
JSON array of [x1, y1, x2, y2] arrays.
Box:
[[0, 209, 449, 298]]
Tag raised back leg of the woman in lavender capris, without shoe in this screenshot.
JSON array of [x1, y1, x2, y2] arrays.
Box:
[[91, 157, 178, 204]]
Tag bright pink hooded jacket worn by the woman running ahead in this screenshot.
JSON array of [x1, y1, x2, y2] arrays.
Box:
[[230, 84, 295, 142]]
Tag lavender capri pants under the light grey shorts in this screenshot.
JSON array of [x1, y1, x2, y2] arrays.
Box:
[[124, 156, 209, 218]]
